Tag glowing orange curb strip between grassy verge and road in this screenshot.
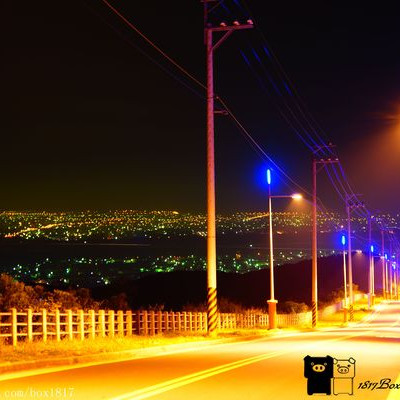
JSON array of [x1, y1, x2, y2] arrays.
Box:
[[0, 335, 262, 375]]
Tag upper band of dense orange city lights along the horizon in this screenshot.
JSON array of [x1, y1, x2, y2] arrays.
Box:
[[0, 210, 400, 242]]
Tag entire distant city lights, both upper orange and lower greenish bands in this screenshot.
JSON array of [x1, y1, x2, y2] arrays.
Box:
[[0, 210, 400, 287]]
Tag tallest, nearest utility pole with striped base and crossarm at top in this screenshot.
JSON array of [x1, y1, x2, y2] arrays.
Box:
[[203, 0, 253, 334]]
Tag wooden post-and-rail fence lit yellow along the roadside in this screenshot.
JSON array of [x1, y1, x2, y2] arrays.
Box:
[[0, 308, 311, 346]]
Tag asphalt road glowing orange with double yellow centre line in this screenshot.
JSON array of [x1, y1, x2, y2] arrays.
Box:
[[0, 302, 400, 400]]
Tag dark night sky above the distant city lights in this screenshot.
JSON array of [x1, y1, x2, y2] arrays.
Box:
[[0, 0, 400, 212]]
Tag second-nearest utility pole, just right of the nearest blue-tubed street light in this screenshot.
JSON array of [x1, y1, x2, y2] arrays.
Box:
[[311, 145, 339, 328]]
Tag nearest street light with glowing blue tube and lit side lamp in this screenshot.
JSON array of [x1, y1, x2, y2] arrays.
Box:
[[267, 169, 303, 329]]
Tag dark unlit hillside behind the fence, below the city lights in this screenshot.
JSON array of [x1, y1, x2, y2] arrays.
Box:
[[90, 253, 381, 310]]
